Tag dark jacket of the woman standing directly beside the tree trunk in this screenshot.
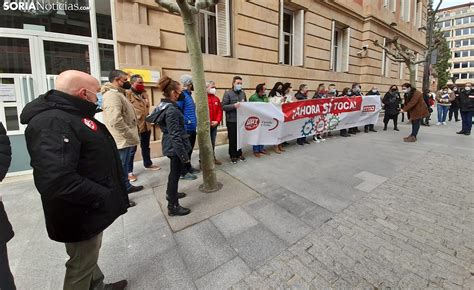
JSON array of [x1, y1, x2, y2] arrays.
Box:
[[153, 99, 192, 163]]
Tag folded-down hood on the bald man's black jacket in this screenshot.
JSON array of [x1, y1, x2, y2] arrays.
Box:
[[20, 90, 97, 124]]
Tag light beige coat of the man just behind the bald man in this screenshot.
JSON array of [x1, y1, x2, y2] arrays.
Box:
[[101, 83, 140, 149]]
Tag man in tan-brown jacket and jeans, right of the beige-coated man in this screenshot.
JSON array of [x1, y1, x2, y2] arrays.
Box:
[[127, 75, 161, 182]]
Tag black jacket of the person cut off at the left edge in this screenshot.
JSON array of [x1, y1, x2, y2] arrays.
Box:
[[0, 122, 14, 244]]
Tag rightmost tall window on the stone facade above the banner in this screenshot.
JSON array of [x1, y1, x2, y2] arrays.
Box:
[[330, 20, 351, 72]]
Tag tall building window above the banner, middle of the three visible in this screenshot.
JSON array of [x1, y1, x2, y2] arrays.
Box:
[[279, 0, 304, 66]]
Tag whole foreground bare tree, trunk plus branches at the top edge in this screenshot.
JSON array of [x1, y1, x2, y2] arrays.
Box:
[[155, 0, 222, 192]]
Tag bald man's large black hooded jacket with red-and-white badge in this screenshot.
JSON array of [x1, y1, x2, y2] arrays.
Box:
[[20, 90, 128, 243]]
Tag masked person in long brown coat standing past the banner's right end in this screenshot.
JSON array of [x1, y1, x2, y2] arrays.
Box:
[[402, 83, 429, 142]]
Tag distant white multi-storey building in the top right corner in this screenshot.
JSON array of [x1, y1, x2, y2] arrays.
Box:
[[437, 2, 474, 84]]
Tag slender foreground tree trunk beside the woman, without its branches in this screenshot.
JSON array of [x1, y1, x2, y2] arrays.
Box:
[[180, 5, 221, 192]]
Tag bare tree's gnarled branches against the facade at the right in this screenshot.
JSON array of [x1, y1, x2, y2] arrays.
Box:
[[373, 36, 425, 87]]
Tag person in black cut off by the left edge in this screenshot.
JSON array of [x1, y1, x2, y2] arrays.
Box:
[[0, 122, 16, 290]]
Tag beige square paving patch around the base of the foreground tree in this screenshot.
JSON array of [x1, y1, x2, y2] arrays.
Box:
[[154, 170, 258, 232]]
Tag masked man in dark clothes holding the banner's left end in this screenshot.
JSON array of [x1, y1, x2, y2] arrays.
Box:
[[222, 76, 247, 164]]
